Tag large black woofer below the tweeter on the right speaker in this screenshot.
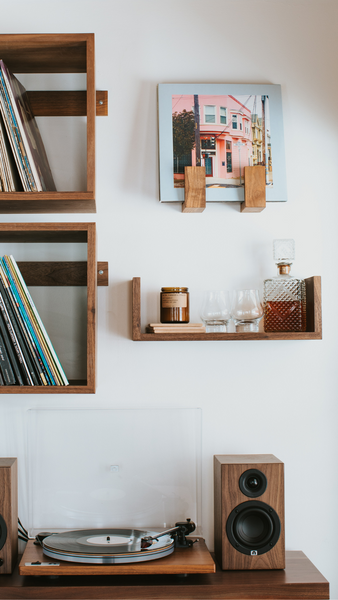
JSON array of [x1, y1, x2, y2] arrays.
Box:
[[226, 500, 281, 555]]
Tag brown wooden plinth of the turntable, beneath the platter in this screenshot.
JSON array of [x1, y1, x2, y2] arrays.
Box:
[[19, 538, 216, 576]]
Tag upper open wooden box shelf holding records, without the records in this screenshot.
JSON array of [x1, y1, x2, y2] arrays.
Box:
[[0, 33, 108, 214]]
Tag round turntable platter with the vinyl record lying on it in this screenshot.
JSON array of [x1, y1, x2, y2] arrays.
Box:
[[42, 529, 175, 564]]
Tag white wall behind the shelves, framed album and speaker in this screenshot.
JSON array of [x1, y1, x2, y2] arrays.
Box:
[[0, 0, 338, 598]]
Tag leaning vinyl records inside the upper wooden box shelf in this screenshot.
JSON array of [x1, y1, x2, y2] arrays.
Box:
[[0, 60, 56, 192]]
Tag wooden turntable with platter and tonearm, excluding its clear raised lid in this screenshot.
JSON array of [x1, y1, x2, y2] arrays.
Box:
[[19, 519, 215, 575]]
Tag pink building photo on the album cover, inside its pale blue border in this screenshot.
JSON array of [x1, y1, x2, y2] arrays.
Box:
[[172, 94, 273, 188]]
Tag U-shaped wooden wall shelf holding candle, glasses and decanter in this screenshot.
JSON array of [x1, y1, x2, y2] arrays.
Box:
[[132, 276, 322, 342]]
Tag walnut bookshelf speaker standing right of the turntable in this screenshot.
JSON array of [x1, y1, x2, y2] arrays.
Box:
[[214, 454, 285, 570]]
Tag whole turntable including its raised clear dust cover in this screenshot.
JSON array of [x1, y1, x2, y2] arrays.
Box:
[[20, 409, 215, 575]]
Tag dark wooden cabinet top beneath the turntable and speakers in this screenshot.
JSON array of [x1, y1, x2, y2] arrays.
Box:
[[0, 551, 330, 600]]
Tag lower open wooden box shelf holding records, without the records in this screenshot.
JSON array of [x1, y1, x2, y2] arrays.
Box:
[[0, 223, 108, 394]]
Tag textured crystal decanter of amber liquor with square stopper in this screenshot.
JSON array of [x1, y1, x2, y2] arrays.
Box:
[[264, 240, 306, 331]]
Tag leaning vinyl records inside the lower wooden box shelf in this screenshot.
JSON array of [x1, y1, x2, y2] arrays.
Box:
[[0, 256, 69, 386]]
